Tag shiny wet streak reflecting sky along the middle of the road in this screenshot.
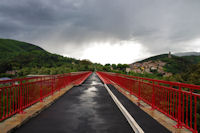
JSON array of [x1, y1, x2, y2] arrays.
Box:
[[73, 76, 105, 131]]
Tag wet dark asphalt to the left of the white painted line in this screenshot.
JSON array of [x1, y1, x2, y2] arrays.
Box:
[[15, 74, 133, 133]]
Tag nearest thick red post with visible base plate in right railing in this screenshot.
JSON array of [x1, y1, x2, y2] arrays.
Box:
[[174, 84, 182, 128]]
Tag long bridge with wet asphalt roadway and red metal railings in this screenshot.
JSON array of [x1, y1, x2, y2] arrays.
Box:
[[0, 72, 200, 133]]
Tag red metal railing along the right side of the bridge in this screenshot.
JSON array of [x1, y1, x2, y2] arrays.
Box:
[[97, 72, 200, 133]]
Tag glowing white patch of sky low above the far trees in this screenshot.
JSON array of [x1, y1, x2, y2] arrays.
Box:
[[81, 41, 150, 64]]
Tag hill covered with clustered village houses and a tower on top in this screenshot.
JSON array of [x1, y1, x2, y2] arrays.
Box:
[[130, 54, 200, 76]]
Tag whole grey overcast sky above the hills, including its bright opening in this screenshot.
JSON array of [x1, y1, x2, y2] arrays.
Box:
[[0, 0, 200, 64]]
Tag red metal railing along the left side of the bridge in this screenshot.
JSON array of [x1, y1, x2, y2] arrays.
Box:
[[0, 72, 91, 121]]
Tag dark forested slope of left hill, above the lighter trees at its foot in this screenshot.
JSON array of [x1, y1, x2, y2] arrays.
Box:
[[0, 39, 77, 73]]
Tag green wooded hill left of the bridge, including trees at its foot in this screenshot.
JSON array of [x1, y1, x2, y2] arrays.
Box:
[[0, 39, 97, 76]]
